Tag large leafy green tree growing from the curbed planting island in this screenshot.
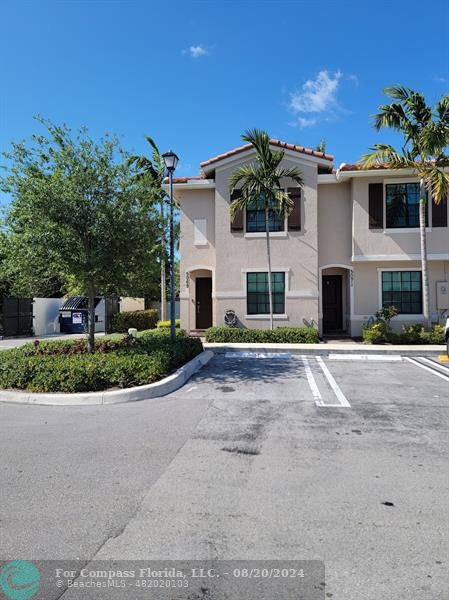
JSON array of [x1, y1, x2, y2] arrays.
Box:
[[1, 118, 159, 352]]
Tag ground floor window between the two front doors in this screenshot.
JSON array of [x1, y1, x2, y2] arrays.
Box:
[[246, 272, 285, 315]]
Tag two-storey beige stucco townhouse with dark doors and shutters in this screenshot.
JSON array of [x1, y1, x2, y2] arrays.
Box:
[[174, 140, 449, 336]]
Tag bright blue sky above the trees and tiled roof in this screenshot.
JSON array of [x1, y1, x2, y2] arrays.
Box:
[[0, 0, 449, 183]]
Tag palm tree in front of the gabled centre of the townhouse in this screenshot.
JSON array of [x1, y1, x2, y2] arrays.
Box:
[[229, 129, 303, 329]]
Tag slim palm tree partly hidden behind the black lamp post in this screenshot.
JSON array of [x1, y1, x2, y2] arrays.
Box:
[[128, 135, 168, 321]]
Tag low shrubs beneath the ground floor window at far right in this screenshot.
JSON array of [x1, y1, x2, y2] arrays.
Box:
[[362, 323, 445, 344]]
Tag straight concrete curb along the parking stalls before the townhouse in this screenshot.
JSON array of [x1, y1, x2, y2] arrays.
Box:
[[203, 343, 446, 356]]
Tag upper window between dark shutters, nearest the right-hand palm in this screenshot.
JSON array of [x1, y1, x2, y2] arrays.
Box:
[[385, 183, 420, 228]]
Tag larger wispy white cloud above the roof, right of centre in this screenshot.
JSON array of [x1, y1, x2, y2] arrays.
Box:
[[290, 70, 343, 113]]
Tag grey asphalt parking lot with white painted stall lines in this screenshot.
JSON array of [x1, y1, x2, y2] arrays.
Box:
[[0, 354, 449, 600]]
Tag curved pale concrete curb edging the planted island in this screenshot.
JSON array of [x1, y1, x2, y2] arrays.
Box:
[[0, 350, 214, 406]]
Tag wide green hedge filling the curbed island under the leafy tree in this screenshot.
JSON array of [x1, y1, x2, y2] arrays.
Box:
[[0, 334, 203, 393]]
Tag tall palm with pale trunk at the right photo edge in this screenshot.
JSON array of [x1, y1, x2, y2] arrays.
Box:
[[362, 86, 449, 329]]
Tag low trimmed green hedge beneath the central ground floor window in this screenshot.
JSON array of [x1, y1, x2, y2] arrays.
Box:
[[205, 327, 319, 344]]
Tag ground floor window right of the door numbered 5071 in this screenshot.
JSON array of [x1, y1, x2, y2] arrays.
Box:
[[382, 271, 422, 315]]
